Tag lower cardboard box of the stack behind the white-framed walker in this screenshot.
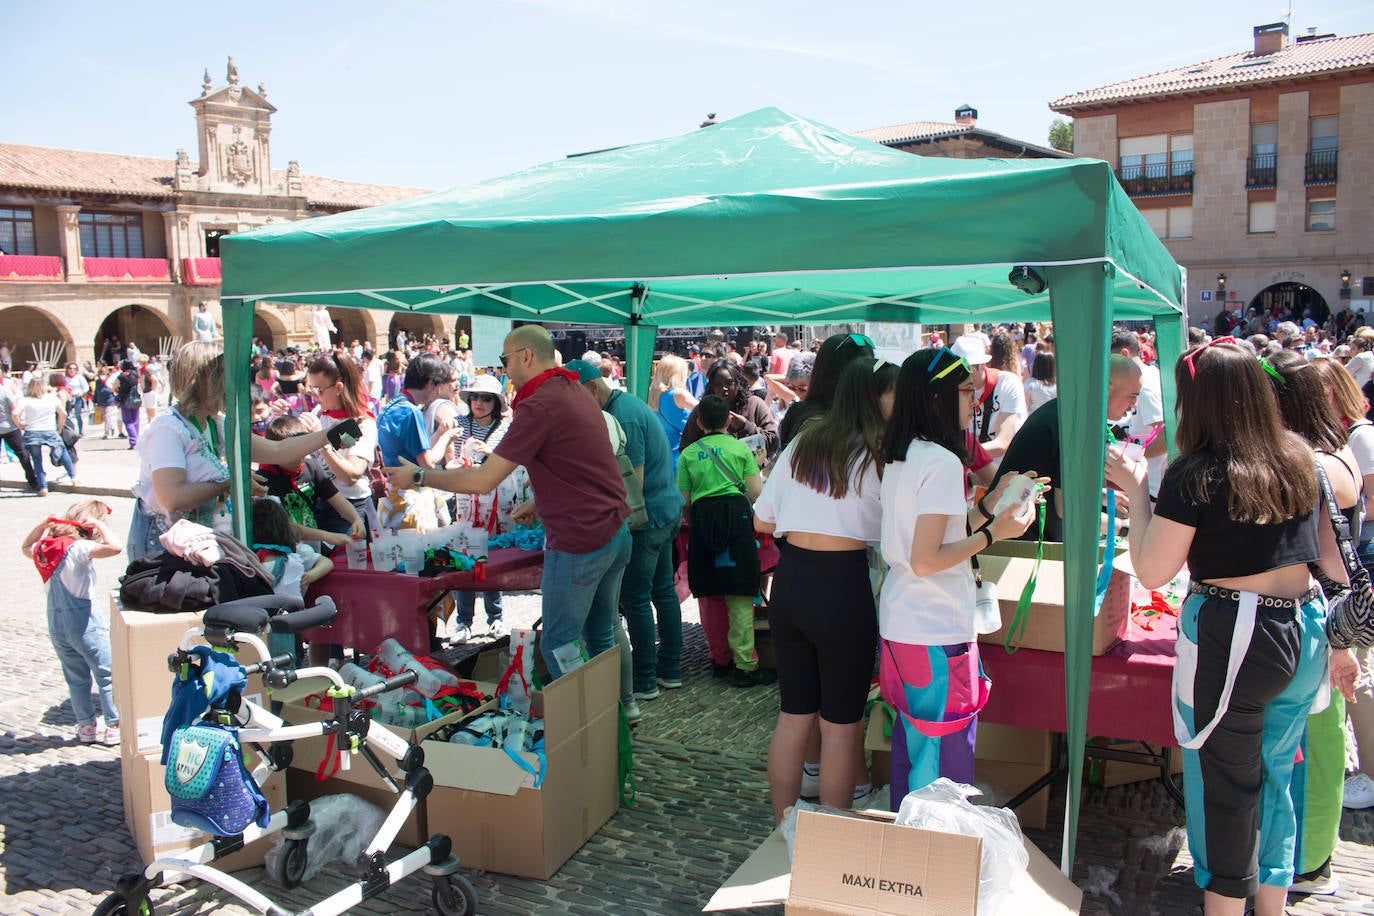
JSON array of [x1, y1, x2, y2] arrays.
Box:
[[120, 751, 287, 872]]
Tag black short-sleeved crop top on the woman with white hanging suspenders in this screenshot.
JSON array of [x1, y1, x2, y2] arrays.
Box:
[[1154, 461, 1325, 581]]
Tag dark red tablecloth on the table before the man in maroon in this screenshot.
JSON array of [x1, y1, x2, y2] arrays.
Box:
[[302, 548, 544, 655]]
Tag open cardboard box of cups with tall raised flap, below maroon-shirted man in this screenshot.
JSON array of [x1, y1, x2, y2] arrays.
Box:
[[418, 647, 620, 880]]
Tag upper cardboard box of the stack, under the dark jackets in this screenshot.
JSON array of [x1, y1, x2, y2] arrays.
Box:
[[110, 592, 264, 757]]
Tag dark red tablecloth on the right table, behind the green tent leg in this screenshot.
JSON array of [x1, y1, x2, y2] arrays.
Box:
[[978, 617, 1178, 747]]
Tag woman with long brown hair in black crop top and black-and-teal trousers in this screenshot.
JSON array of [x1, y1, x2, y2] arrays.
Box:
[[1106, 338, 1327, 916]]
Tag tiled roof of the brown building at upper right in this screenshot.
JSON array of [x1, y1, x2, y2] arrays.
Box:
[[1050, 32, 1374, 113]]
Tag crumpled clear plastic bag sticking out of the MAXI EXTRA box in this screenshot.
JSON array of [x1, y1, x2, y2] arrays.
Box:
[[897, 777, 1031, 913]]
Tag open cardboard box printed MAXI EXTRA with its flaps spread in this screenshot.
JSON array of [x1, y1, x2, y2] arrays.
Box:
[[706, 812, 1083, 916]]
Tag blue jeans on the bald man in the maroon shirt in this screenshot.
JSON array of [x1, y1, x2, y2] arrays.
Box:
[[539, 523, 631, 678]]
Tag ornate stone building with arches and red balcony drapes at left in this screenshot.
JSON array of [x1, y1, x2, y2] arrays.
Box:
[[0, 58, 434, 365]]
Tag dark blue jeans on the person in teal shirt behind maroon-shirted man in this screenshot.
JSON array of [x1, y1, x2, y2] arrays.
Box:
[[620, 519, 683, 692]]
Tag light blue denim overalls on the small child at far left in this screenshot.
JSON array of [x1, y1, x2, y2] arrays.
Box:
[[48, 575, 120, 725]]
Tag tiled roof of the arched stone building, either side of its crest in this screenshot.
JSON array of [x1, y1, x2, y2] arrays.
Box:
[[0, 143, 425, 207]]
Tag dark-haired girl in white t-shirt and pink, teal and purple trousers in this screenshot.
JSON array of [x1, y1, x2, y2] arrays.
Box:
[[878, 347, 1035, 810]]
